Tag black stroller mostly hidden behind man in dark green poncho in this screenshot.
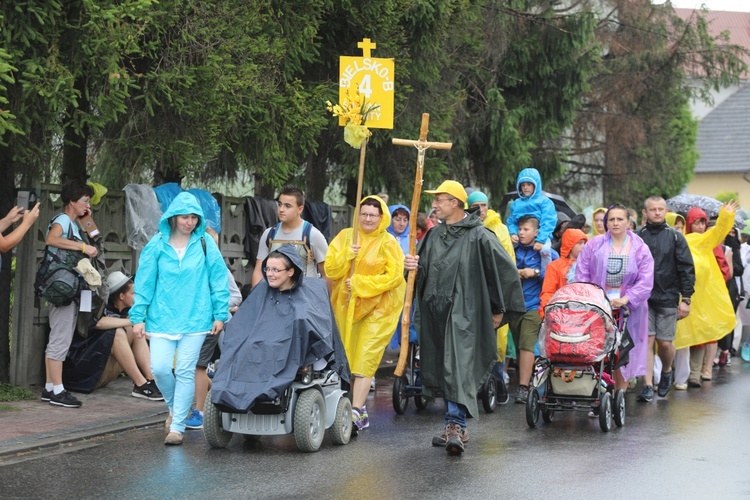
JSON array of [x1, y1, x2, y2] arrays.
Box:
[[393, 343, 500, 415]]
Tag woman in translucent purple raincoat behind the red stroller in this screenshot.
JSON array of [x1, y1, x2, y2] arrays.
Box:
[[575, 204, 654, 397]]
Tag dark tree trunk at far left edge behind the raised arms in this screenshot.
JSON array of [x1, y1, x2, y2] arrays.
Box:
[[0, 137, 16, 382]]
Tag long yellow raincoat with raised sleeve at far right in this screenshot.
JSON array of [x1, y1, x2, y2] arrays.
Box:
[[674, 209, 736, 349]]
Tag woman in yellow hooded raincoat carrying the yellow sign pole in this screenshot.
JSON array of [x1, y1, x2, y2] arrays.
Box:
[[325, 196, 406, 429]]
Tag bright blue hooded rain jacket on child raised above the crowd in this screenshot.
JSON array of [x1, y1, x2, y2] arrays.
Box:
[[505, 168, 557, 244]]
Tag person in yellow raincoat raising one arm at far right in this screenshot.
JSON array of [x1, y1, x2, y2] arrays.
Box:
[[674, 202, 739, 390]]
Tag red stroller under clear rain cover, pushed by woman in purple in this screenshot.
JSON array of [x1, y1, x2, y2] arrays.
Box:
[[526, 283, 632, 432]]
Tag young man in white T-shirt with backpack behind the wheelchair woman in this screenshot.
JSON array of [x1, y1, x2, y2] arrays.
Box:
[[252, 186, 328, 286]]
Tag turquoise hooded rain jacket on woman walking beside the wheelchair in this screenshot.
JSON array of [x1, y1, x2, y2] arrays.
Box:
[[130, 192, 229, 335]]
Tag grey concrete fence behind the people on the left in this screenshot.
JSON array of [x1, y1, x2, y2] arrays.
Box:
[[10, 184, 353, 387]]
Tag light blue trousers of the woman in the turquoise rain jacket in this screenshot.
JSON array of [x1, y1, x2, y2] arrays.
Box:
[[151, 335, 206, 432]]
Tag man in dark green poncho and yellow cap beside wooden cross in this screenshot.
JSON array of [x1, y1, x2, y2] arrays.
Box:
[[404, 181, 526, 454]]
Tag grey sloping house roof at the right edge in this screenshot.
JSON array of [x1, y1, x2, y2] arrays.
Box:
[[695, 84, 750, 174]]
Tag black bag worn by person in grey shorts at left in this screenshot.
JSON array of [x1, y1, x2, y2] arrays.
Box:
[[34, 216, 84, 307]]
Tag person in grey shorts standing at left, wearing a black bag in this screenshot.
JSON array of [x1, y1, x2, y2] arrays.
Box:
[[42, 180, 98, 408]]
